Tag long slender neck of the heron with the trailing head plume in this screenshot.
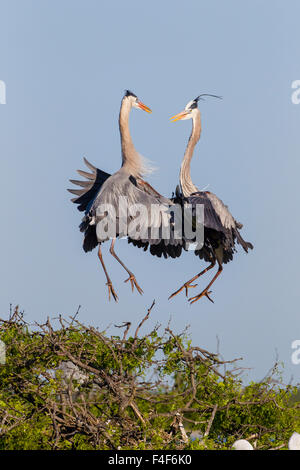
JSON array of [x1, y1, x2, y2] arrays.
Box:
[[179, 112, 201, 197]]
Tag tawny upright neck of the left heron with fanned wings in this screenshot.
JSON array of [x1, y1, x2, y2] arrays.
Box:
[[119, 99, 143, 177]]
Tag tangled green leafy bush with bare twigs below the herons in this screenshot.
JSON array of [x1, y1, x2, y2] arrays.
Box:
[[0, 307, 300, 450]]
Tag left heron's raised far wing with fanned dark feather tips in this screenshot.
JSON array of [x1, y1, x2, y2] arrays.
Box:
[[68, 158, 111, 213]]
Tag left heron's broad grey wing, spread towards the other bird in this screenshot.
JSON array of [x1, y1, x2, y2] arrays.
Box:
[[80, 168, 182, 256]]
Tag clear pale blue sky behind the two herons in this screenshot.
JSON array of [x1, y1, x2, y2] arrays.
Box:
[[0, 0, 300, 380]]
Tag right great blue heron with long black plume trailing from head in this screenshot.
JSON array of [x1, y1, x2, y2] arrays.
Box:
[[169, 94, 253, 303]]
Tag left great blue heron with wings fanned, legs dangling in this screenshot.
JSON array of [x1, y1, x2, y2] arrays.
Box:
[[69, 90, 182, 301]]
